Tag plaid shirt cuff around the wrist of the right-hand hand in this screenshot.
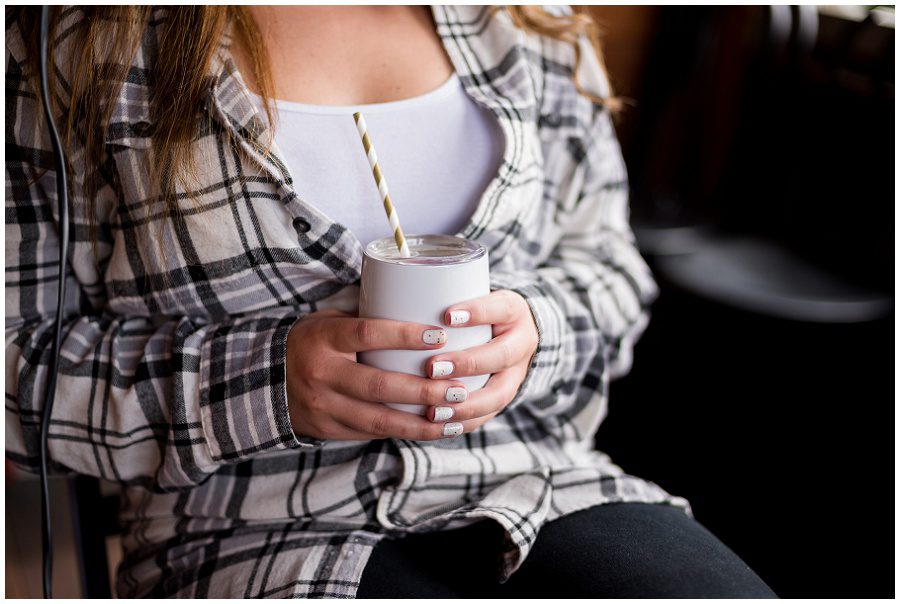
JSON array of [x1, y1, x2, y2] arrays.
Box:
[[491, 274, 567, 408]]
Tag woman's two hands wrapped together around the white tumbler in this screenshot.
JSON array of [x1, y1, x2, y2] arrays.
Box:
[[287, 290, 538, 440]]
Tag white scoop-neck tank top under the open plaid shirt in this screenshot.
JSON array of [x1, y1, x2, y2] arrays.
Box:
[[254, 74, 504, 245]]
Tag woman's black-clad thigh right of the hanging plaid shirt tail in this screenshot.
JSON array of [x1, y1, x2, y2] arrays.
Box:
[[498, 503, 777, 598]]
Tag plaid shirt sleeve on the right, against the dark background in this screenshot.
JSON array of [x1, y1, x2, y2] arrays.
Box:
[[492, 30, 658, 414]]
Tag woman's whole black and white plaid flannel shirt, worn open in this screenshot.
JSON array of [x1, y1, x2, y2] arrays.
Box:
[[6, 6, 690, 597]]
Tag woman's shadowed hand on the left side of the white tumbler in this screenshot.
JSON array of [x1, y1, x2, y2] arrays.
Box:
[[286, 310, 478, 440]]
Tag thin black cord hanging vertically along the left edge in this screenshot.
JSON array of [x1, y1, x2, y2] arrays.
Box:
[[40, 6, 69, 598]]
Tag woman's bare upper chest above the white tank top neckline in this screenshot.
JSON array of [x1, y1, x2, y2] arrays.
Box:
[[232, 6, 453, 105]]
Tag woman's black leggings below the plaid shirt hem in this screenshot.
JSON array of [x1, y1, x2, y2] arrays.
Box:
[[357, 503, 777, 598]]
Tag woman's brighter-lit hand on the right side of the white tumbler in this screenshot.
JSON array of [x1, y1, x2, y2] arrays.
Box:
[[425, 289, 538, 432]]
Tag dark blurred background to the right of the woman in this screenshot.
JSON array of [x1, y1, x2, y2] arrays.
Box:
[[579, 6, 894, 598]]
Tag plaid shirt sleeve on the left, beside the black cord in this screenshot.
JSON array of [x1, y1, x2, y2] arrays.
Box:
[[5, 35, 322, 490]]
